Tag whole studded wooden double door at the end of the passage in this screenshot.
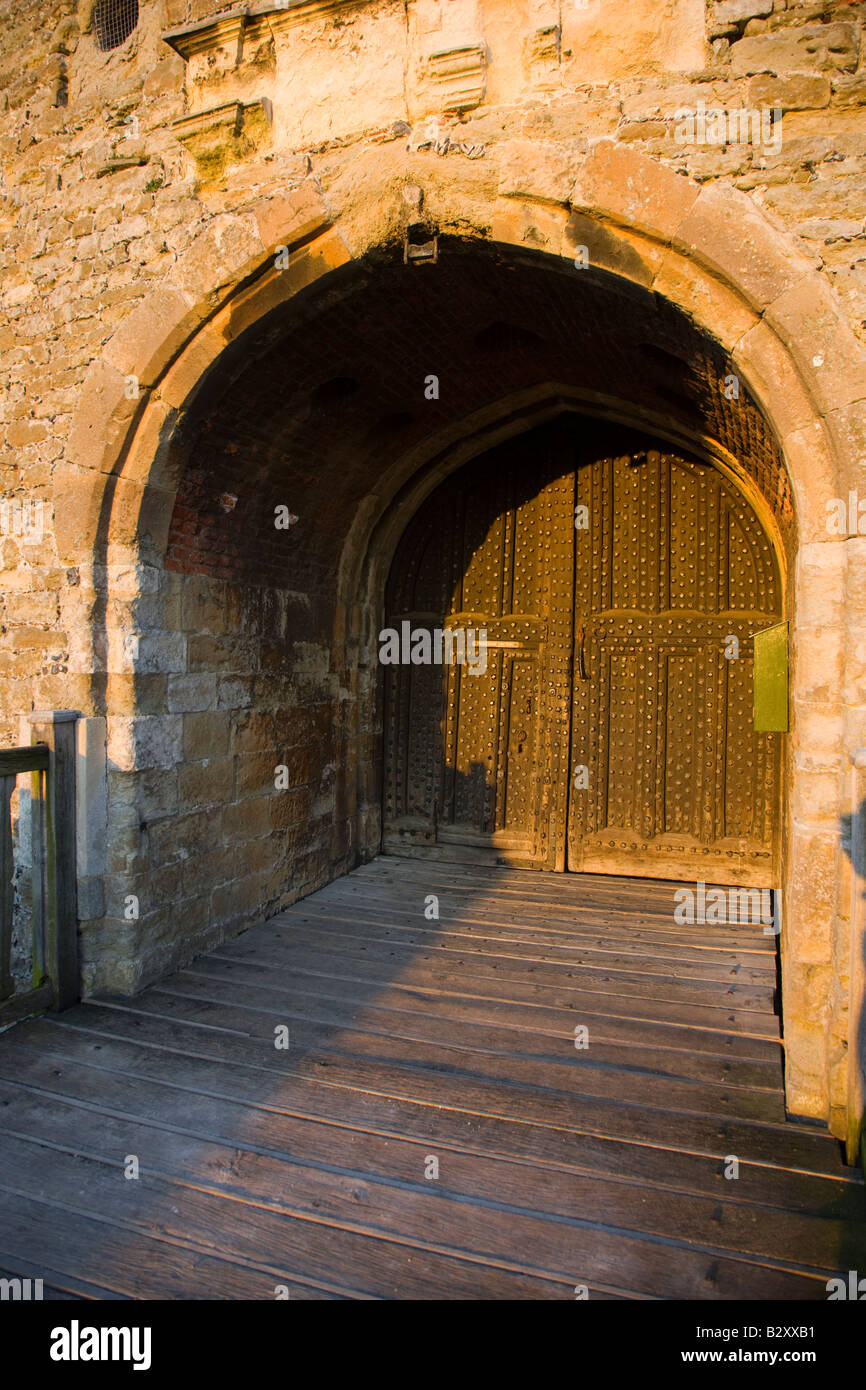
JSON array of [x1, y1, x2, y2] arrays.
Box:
[[384, 423, 781, 887]]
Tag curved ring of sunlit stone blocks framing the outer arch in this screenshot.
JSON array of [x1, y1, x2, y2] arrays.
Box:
[[58, 140, 866, 560]]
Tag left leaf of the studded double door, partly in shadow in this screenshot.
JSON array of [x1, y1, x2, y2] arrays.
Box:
[[384, 428, 574, 869]]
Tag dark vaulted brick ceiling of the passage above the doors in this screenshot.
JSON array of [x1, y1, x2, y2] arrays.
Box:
[[167, 239, 792, 596]]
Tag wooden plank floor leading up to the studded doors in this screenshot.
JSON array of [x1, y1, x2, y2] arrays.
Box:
[[0, 858, 866, 1300]]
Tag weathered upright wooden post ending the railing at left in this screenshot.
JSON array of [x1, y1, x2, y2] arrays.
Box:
[[29, 709, 79, 1009]]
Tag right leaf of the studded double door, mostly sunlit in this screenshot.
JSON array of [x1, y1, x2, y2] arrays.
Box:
[[569, 449, 781, 887]]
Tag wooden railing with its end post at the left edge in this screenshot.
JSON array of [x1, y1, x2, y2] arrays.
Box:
[[0, 710, 79, 1026]]
